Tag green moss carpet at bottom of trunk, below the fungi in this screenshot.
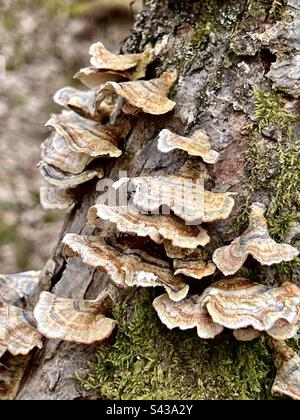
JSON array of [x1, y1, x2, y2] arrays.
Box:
[[78, 292, 274, 400]]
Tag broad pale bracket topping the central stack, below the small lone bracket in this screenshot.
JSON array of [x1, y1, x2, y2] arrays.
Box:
[[113, 175, 234, 222]]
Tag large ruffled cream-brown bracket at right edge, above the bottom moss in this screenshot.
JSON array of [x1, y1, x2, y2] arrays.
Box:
[[201, 277, 300, 339]]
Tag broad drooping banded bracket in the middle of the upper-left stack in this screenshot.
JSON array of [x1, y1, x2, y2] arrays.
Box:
[[46, 112, 129, 158]]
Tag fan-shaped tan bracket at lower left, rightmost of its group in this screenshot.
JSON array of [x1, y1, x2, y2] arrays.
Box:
[[34, 292, 117, 344]]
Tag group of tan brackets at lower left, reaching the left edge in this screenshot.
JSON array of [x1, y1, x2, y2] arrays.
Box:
[[0, 271, 117, 357]]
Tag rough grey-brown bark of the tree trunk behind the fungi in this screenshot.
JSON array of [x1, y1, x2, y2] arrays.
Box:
[[18, 0, 300, 399]]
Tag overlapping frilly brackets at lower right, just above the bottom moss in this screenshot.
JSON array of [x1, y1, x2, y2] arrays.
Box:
[[153, 277, 300, 341]]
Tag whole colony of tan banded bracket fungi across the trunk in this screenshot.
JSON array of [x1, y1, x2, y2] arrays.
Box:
[[27, 37, 300, 398]]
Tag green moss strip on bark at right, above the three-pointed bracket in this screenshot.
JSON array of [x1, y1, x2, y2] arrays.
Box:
[[234, 88, 300, 281]]
